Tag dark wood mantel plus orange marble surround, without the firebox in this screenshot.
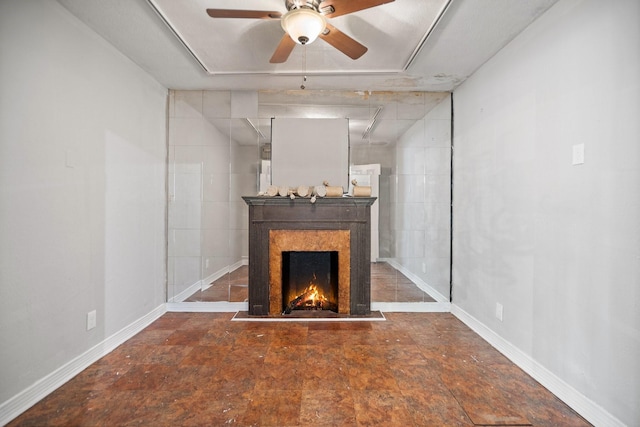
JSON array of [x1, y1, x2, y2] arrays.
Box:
[[243, 197, 376, 316]]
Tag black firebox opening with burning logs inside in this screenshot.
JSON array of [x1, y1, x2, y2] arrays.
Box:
[[282, 251, 338, 314]]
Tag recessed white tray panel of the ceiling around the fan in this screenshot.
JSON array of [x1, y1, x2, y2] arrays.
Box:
[[149, 0, 448, 75]]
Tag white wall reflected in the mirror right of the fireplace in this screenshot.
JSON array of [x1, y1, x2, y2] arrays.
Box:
[[391, 97, 451, 301]]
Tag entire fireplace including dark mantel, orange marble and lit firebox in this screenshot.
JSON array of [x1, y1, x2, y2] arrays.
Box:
[[243, 197, 375, 316]]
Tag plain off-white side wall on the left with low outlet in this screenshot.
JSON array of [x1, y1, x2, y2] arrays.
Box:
[[0, 1, 167, 412]]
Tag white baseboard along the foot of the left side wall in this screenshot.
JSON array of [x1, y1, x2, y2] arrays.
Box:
[[0, 304, 167, 425]]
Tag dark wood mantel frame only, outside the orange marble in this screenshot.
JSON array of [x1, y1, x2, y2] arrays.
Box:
[[243, 197, 376, 316]]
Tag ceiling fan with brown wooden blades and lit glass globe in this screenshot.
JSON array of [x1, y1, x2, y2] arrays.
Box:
[[207, 0, 394, 64]]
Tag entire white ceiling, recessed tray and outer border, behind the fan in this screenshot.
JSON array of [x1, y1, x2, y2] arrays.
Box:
[[58, 0, 557, 92]]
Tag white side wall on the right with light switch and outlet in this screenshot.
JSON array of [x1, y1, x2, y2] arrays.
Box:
[[453, 0, 640, 426]]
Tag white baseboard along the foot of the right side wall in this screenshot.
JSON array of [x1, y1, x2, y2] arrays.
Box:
[[451, 304, 624, 427]]
